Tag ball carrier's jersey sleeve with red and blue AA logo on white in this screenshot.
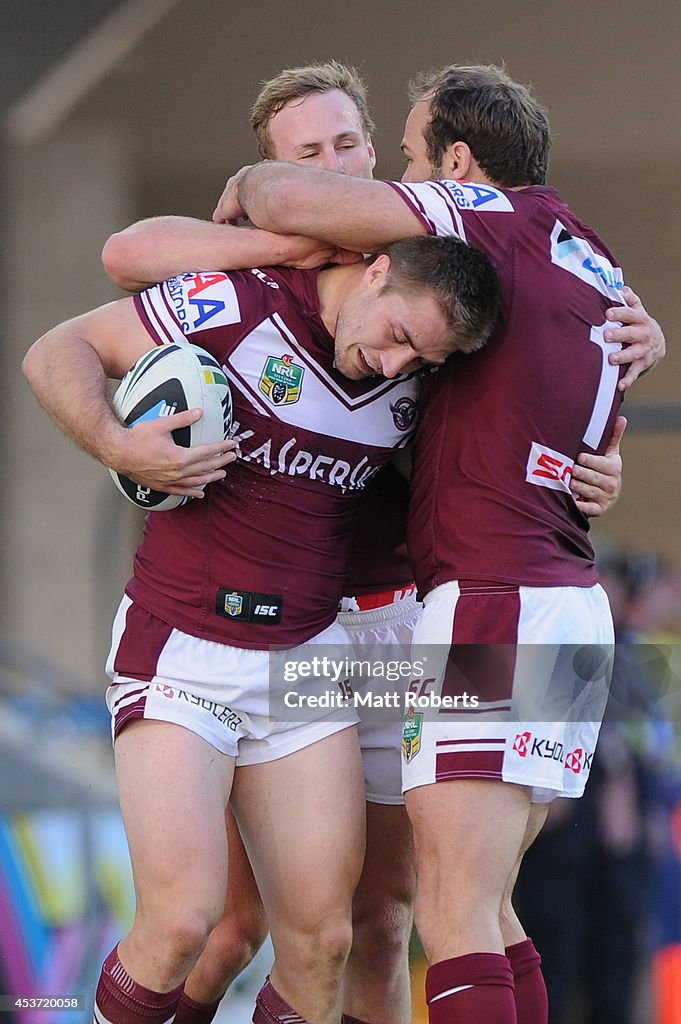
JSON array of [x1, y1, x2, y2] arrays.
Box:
[[134, 271, 248, 354]]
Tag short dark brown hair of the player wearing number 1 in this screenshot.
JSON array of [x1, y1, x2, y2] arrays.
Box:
[[410, 65, 551, 188]]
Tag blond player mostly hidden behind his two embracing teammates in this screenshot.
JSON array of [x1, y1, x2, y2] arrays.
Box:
[[104, 61, 656, 1024]]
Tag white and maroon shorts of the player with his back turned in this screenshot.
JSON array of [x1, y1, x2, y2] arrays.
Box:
[[402, 581, 614, 803]]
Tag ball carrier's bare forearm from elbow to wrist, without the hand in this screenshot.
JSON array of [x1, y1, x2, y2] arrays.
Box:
[[22, 327, 129, 466]]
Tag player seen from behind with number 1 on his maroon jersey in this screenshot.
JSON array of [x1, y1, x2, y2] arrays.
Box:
[[216, 66, 664, 1024]]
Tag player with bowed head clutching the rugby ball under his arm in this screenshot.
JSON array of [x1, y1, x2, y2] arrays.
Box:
[[23, 239, 498, 1024]]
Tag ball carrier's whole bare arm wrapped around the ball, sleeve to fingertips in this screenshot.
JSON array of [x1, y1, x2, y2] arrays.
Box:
[[22, 299, 235, 498]]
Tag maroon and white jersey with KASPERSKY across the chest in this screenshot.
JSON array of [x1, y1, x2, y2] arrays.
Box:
[[127, 268, 418, 649]]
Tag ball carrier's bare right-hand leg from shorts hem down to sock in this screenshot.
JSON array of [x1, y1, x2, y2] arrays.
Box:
[[232, 728, 365, 1022]]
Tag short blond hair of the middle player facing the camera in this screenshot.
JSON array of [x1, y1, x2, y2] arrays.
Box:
[[251, 60, 374, 160]]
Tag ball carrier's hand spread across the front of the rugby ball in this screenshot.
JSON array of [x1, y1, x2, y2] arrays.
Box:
[[111, 409, 237, 498]]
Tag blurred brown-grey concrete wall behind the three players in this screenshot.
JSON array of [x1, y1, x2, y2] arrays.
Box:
[[0, 0, 681, 688]]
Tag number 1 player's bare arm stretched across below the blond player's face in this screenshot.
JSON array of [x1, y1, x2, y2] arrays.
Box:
[[227, 161, 426, 252]]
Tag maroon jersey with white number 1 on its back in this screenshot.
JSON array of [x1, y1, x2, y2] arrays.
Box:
[[391, 181, 623, 594]]
